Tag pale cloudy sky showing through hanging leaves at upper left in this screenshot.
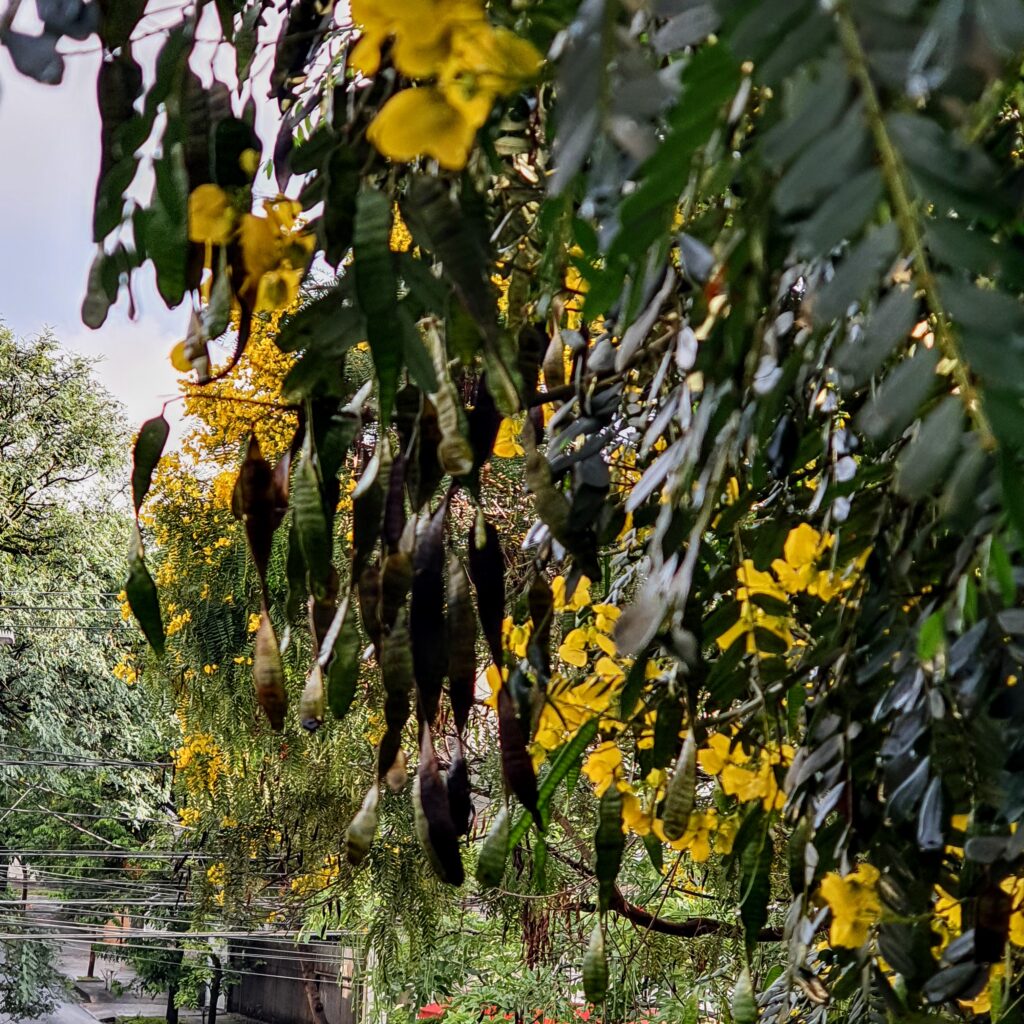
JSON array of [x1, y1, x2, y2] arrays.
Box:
[[0, 0, 296, 425]]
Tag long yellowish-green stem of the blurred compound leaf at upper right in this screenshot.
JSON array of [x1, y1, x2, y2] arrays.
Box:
[[836, 3, 995, 450]]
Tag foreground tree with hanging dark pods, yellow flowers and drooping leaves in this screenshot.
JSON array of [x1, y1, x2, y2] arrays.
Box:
[[5, 0, 1024, 1021]]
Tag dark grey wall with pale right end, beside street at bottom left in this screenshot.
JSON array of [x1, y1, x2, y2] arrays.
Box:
[[227, 939, 358, 1024]]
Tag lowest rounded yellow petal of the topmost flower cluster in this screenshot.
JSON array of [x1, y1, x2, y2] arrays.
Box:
[[367, 86, 476, 171]]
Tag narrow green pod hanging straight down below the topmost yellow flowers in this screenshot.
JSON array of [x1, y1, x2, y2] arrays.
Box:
[[352, 189, 403, 423]]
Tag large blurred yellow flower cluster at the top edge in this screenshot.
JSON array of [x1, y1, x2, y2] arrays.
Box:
[[349, 0, 541, 171]]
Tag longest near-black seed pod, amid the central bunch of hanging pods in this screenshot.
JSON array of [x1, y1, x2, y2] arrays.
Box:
[[409, 501, 447, 726]]
